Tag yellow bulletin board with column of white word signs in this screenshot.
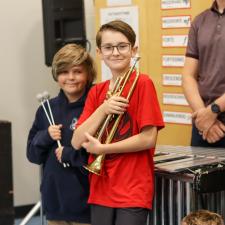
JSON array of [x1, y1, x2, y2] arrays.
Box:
[[94, 0, 213, 145]]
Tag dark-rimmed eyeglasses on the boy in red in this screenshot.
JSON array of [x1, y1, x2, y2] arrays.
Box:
[[101, 43, 130, 56]]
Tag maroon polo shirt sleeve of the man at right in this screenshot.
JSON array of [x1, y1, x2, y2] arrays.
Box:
[[186, 19, 199, 59]]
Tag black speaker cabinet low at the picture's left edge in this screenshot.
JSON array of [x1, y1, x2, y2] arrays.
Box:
[[0, 121, 14, 225]]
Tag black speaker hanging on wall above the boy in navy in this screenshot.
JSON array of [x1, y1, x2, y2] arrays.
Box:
[[42, 0, 86, 66]]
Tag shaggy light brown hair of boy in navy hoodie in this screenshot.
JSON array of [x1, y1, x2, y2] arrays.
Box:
[[52, 44, 96, 86]]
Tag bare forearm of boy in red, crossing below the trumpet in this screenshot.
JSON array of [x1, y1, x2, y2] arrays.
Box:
[[82, 126, 157, 154]]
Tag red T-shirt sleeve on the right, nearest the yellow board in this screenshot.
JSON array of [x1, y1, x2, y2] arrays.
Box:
[[137, 78, 164, 132]]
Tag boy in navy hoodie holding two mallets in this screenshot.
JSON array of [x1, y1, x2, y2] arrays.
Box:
[[27, 44, 96, 225]]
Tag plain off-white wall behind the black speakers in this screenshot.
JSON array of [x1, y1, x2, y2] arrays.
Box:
[[0, 0, 95, 206]]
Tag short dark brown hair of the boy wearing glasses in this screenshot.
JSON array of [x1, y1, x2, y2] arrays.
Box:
[[96, 20, 136, 48]]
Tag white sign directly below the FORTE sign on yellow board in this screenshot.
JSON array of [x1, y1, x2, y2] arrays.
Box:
[[162, 55, 185, 67]]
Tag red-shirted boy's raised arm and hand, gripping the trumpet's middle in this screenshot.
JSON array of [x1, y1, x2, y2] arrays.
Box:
[[72, 96, 128, 149]]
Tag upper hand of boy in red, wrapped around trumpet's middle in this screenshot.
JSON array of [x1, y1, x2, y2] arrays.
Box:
[[103, 96, 129, 115]]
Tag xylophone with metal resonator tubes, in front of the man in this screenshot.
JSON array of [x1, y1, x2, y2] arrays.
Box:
[[148, 146, 225, 225]]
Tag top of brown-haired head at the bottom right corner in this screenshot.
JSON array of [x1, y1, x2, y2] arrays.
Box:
[[182, 210, 224, 225]]
